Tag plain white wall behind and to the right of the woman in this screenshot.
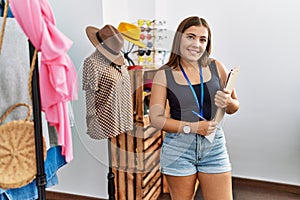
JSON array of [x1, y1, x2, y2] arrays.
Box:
[[162, 0, 300, 185]]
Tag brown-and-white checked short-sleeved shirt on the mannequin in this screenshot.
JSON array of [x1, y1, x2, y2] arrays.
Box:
[[82, 50, 133, 139]]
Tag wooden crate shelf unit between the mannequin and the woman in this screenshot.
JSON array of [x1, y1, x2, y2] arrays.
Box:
[[111, 69, 164, 200]]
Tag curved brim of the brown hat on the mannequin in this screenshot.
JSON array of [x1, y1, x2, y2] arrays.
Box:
[[86, 26, 125, 65]]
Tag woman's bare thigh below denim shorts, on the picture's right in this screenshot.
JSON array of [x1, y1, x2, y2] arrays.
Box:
[[198, 172, 232, 200]]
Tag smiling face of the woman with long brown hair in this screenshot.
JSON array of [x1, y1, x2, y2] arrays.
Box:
[[180, 26, 208, 62]]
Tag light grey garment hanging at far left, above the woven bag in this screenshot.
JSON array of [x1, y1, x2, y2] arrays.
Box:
[[0, 18, 31, 121]]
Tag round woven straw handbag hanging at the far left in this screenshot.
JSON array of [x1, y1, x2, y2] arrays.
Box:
[[0, 103, 46, 189]]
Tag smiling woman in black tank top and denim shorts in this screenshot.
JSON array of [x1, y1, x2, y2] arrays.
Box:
[[150, 16, 239, 200]]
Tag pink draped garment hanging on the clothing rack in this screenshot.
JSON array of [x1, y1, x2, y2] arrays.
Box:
[[10, 0, 78, 162]]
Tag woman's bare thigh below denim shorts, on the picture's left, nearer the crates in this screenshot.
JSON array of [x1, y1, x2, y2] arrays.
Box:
[[165, 174, 197, 200]]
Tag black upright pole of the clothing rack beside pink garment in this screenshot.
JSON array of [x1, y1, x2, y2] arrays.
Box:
[[28, 40, 47, 200]]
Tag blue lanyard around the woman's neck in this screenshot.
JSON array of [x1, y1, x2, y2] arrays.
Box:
[[179, 63, 204, 118]]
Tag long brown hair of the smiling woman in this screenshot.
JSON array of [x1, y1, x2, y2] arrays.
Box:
[[162, 16, 212, 68]]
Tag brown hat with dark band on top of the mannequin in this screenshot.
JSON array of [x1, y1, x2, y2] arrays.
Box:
[[85, 25, 125, 65]]
